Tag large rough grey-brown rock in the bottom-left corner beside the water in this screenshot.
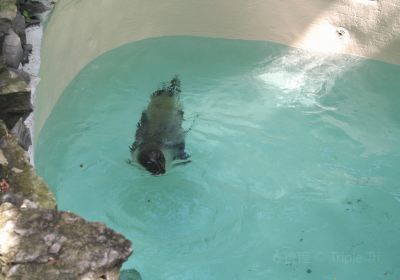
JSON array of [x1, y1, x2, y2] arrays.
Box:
[[0, 203, 132, 280]]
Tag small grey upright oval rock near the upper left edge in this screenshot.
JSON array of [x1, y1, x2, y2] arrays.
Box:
[[2, 29, 23, 69]]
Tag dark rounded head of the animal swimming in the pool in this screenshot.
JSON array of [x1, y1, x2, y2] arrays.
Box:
[[138, 148, 165, 175]]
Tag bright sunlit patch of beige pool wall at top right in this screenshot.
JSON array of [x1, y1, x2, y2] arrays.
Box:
[[293, 0, 400, 57]]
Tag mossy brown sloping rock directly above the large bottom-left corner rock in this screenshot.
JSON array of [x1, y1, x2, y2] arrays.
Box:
[[0, 121, 56, 209]]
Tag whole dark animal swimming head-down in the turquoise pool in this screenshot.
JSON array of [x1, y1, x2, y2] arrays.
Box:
[[130, 76, 189, 175]]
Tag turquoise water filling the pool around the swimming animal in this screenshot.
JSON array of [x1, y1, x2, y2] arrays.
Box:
[[36, 37, 400, 280]]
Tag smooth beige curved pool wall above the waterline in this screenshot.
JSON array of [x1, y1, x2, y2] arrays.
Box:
[[34, 0, 400, 142]]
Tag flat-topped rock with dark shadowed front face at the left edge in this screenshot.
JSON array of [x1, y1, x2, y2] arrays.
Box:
[[0, 65, 32, 129]]
